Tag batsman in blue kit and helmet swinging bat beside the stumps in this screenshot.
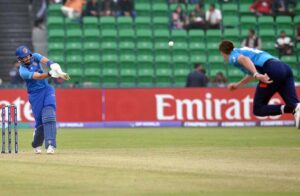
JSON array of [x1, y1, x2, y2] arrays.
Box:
[[16, 46, 70, 154]]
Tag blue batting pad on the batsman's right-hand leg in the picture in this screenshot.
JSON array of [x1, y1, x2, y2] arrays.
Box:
[[42, 106, 56, 149]]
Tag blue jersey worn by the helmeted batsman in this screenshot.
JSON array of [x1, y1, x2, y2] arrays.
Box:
[[19, 53, 49, 93]]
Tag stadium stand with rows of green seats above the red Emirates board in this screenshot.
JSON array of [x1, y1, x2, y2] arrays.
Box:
[[0, 0, 300, 87]]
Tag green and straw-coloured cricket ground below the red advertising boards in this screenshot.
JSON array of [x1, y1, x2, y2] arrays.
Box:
[[0, 127, 300, 196]]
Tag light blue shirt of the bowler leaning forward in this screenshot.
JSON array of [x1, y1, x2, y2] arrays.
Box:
[[229, 47, 277, 75]]
